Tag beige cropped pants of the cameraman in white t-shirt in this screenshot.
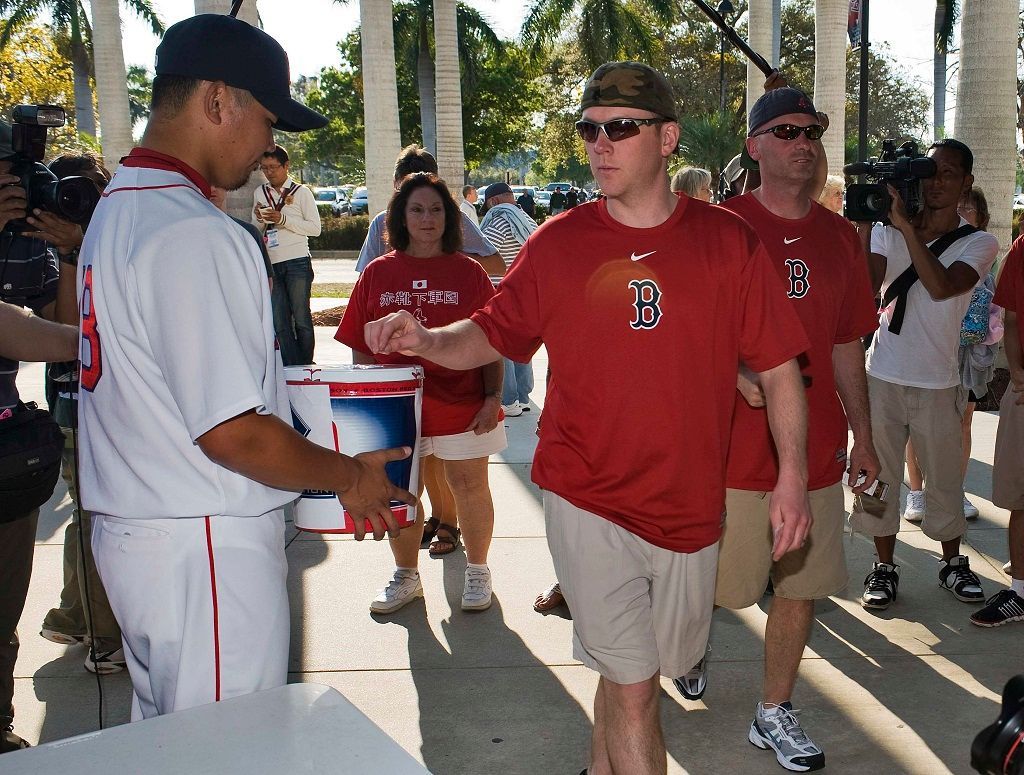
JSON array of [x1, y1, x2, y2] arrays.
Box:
[[850, 375, 967, 541]]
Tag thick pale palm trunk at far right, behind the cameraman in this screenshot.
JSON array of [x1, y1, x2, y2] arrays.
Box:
[[954, 0, 1019, 250]]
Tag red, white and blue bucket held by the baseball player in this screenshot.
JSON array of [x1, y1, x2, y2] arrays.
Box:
[[285, 365, 423, 533]]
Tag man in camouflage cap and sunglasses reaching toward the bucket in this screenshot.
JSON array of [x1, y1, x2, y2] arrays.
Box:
[[366, 62, 810, 775]]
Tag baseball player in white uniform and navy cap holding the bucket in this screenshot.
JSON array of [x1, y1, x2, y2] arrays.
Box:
[[79, 14, 414, 719]]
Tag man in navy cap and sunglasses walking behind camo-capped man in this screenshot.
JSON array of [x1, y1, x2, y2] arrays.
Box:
[[692, 87, 880, 771]]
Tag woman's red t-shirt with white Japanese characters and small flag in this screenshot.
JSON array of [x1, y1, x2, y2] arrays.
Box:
[[334, 251, 495, 436]]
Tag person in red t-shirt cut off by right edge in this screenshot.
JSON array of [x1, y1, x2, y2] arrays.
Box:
[[971, 235, 1024, 627]]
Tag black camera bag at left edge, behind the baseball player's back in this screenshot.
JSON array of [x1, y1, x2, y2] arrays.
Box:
[[0, 402, 65, 522]]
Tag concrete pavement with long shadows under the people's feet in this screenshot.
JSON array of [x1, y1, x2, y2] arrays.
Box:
[[9, 323, 1024, 775]]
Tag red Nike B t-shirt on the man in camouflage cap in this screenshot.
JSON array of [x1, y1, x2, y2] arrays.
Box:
[[472, 197, 807, 552]]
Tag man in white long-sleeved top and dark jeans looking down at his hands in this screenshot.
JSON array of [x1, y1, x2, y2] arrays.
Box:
[[253, 145, 321, 365]]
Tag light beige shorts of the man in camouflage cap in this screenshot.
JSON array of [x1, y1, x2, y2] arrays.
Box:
[[544, 491, 718, 684]]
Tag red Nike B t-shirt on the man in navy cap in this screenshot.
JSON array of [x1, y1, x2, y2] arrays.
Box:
[[722, 193, 879, 490]]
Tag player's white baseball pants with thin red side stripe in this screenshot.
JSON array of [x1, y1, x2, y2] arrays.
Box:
[[92, 510, 290, 721]]
